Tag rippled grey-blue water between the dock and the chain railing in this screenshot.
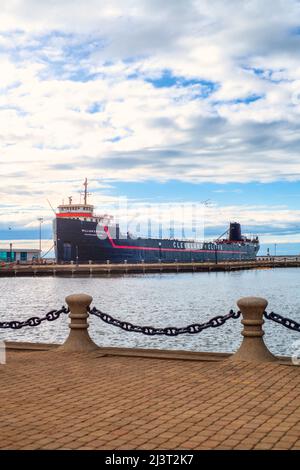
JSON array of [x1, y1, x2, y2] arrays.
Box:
[[0, 268, 300, 355]]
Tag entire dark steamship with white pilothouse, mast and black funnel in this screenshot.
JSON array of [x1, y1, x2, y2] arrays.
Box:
[[53, 179, 259, 263]]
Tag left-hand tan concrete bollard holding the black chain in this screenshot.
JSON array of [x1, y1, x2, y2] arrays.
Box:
[[59, 294, 98, 352]]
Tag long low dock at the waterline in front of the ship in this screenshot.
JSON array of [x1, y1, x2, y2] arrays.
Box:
[[0, 255, 300, 277]]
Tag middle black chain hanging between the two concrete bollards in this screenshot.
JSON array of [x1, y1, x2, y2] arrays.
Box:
[[89, 307, 241, 336]]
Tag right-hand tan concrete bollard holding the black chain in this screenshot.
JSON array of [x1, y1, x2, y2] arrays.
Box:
[[230, 297, 277, 362]]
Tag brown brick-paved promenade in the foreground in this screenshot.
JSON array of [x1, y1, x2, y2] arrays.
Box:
[[0, 349, 300, 450]]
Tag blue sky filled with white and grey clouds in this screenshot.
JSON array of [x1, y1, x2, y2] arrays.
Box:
[[0, 0, 300, 253]]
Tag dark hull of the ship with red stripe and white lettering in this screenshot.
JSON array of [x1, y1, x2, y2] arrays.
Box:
[[54, 218, 259, 263]]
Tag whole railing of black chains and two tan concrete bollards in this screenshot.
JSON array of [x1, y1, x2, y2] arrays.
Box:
[[0, 294, 294, 364]]
